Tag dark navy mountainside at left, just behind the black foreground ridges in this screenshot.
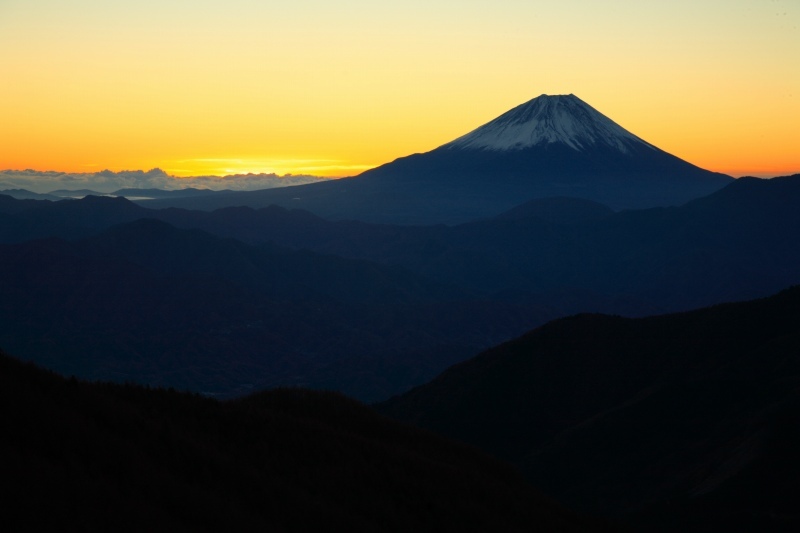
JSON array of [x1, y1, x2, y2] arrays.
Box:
[[0, 216, 552, 399]]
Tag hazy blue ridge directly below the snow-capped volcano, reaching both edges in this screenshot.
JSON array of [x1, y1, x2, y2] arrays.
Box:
[[0, 175, 800, 318]]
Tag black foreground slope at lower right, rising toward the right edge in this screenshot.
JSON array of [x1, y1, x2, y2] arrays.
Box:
[[379, 287, 800, 532]]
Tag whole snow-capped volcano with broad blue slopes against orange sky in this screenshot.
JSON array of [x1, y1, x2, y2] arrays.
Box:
[[148, 94, 733, 224]]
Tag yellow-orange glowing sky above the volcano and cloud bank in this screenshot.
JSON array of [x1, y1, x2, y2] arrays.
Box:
[[0, 0, 800, 181]]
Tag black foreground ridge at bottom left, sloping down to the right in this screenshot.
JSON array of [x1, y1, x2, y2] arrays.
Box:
[[0, 352, 604, 532]]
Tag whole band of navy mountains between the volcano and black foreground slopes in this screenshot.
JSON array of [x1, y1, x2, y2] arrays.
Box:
[[0, 176, 800, 400]]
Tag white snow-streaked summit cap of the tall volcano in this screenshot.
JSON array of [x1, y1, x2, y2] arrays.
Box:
[[441, 94, 653, 153]]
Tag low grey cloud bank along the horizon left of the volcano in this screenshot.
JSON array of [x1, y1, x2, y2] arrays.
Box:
[[0, 168, 331, 194]]
